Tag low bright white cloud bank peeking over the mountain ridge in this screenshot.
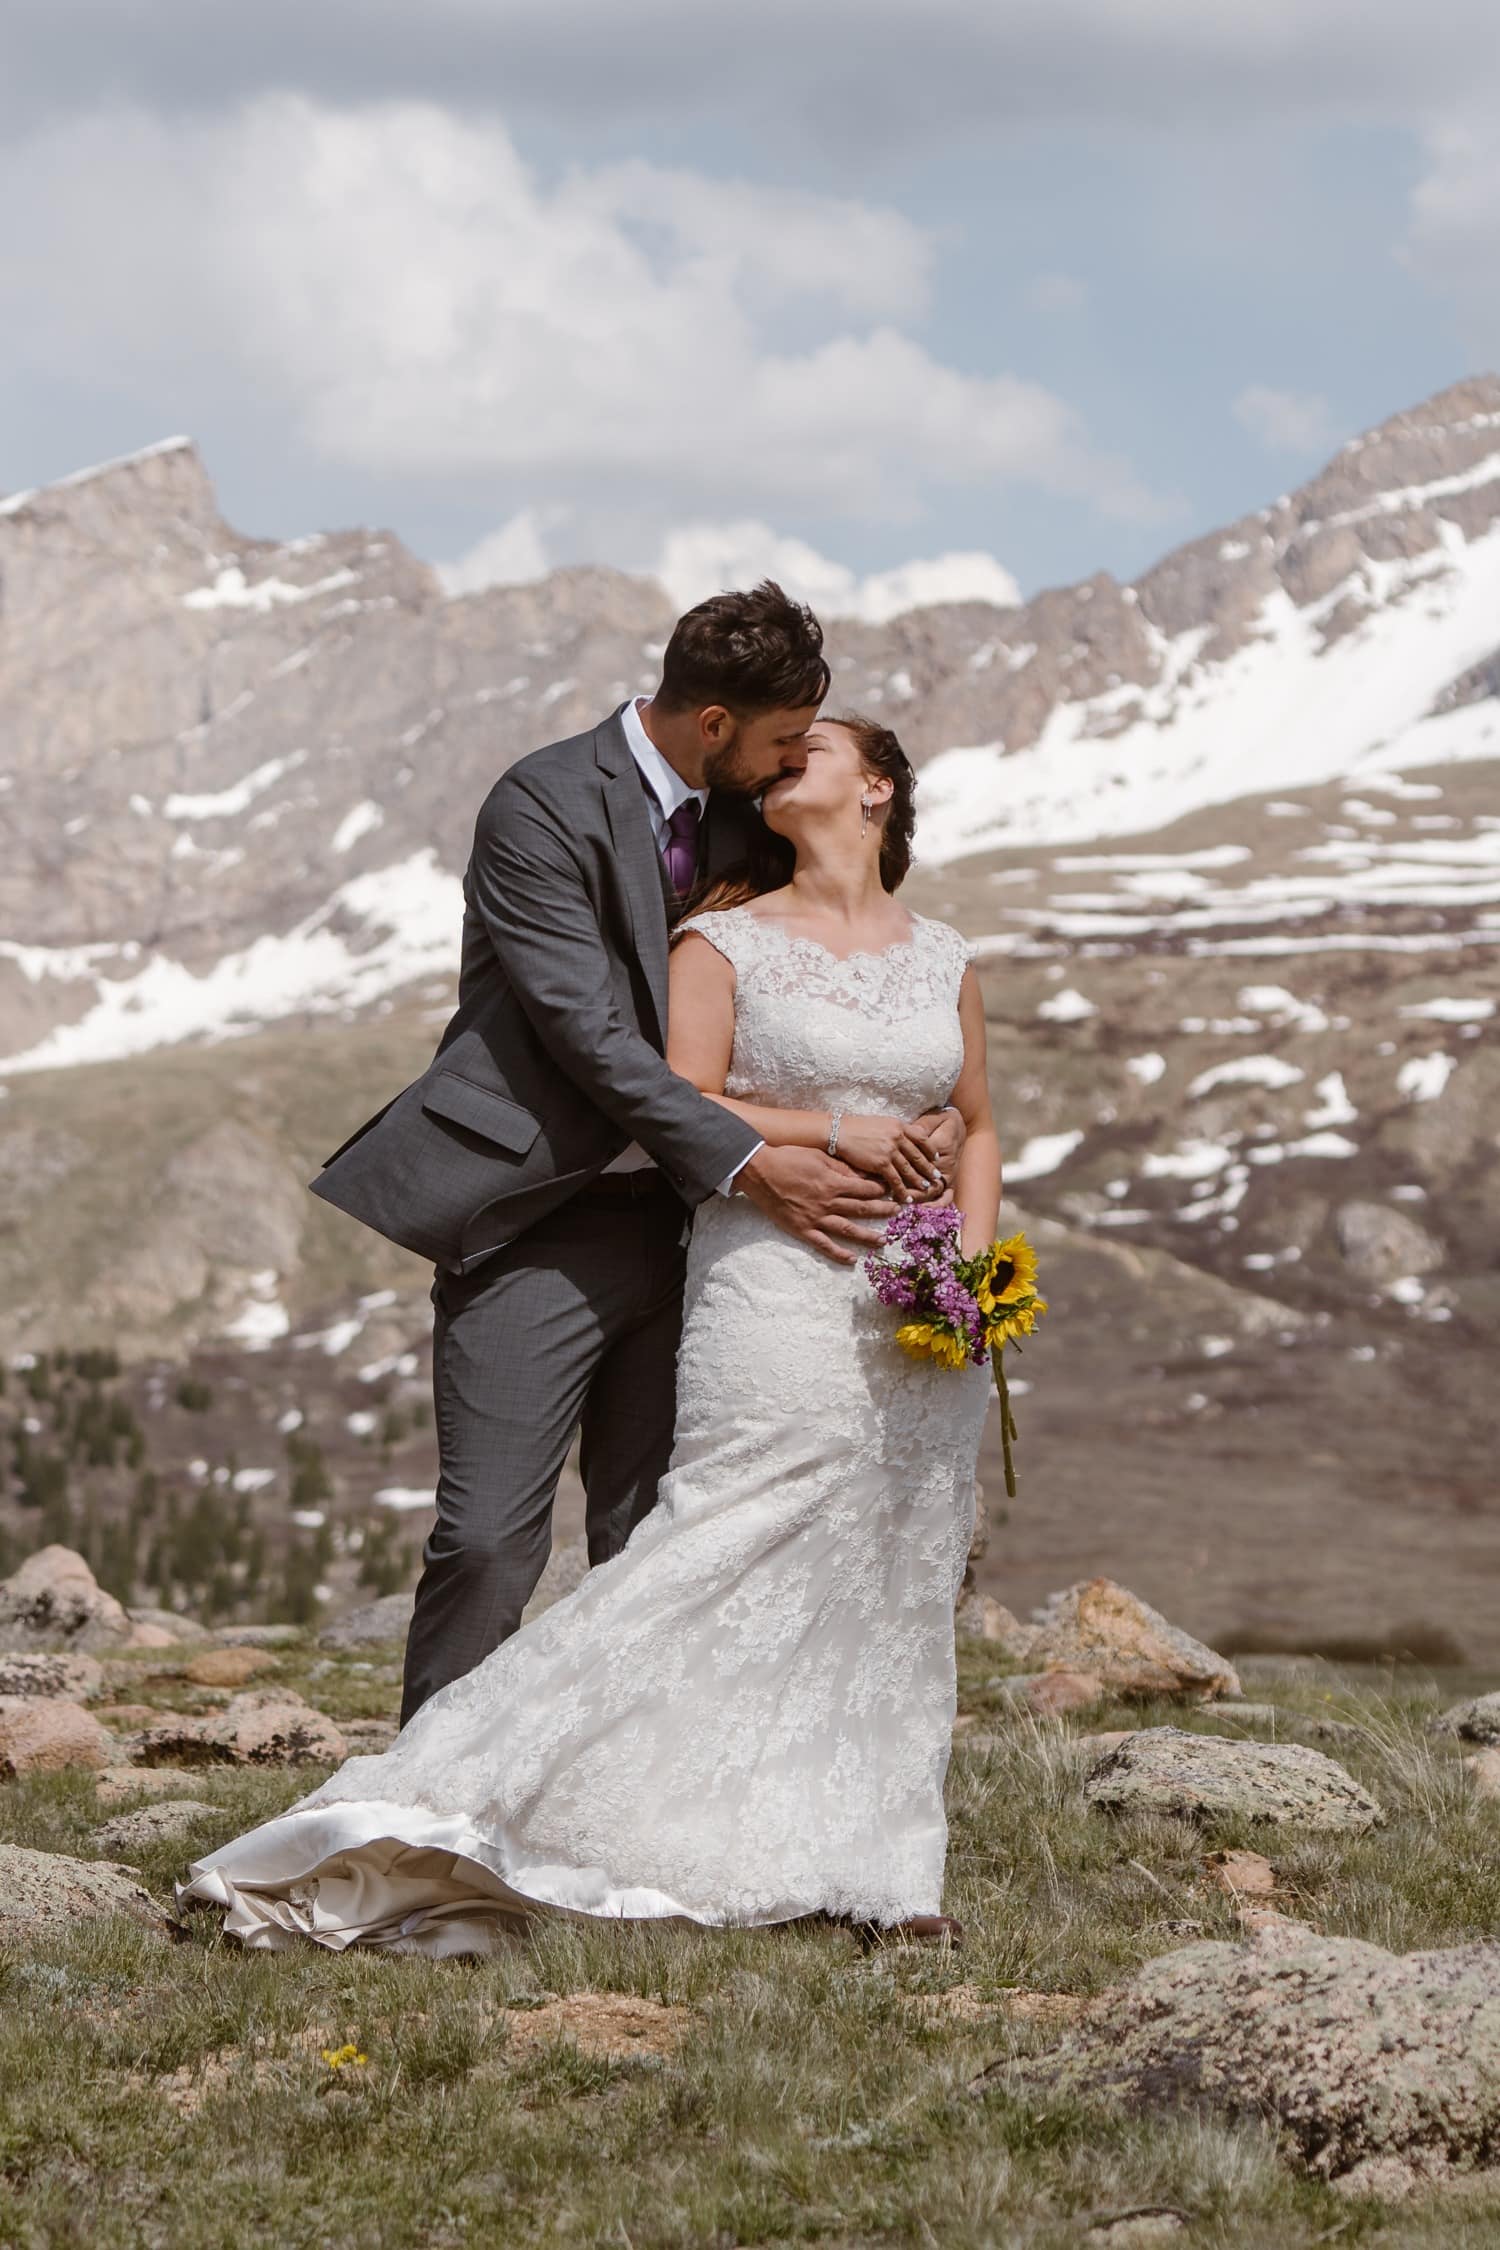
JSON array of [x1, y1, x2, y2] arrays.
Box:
[[439, 509, 1021, 626]]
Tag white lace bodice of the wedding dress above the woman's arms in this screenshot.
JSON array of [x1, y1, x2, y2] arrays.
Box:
[[677, 907, 972, 1118]]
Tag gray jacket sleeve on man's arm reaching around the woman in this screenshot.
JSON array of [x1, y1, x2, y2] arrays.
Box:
[[470, 781, 758, 1204]]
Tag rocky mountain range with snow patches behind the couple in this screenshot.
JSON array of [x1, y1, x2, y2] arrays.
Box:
[[0, 376, 1500, 1073]]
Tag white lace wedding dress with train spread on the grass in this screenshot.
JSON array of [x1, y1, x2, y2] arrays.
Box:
[[180, 907, 990, 1953]]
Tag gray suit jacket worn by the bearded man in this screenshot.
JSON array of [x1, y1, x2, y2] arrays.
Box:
[[313, 711, 758, 1274]]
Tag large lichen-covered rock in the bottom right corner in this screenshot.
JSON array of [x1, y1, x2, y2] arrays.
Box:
[[990, 1922, 1500, 2185]]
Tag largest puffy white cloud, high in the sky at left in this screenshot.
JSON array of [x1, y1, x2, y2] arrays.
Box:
[[0, 95, 1158, 522]]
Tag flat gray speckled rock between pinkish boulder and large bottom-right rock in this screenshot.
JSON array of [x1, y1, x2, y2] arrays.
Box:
[[1084, 1726, 1385, 1829]]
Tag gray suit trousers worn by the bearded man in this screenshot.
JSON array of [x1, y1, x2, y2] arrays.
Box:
[[400, 1172, 688, 1726]]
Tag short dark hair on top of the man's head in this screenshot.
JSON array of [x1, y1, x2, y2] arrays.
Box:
[[657, 578, 832, 718]]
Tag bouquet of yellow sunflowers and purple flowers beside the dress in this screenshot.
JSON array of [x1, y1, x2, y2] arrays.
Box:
[[864, 1204, 1048, 1501]]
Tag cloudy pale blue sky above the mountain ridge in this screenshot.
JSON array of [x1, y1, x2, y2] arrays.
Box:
[[0, 0, 1500, 608]]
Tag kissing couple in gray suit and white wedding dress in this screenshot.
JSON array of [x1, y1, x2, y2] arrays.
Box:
[[191, 583, 1001, 1955]]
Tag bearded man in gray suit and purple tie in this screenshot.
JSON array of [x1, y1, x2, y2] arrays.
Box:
[[313, 583, 958, 1726]]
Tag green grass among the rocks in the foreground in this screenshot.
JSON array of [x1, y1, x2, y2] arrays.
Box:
[[0, 1647, 1500, 2250]]
